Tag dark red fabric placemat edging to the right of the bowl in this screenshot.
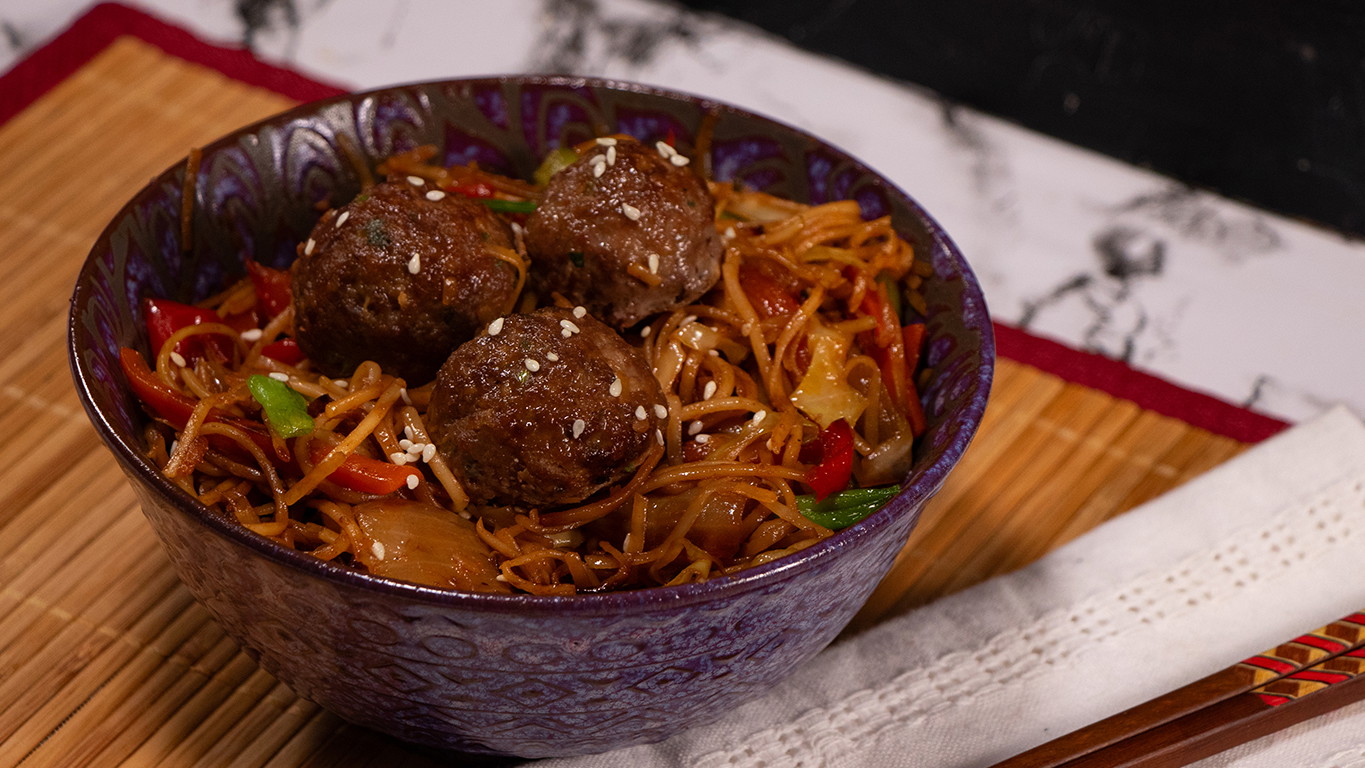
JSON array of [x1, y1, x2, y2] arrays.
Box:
[[995, 323, 1289, 442]]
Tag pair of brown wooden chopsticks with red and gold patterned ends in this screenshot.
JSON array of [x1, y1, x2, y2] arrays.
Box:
[[992, 611, 1365, 768]]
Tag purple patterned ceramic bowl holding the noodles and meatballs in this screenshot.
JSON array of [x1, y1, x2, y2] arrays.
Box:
[[70, 76, 994, 757]]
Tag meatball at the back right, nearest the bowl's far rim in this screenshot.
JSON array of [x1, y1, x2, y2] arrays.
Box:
[[526, 139, 723, 329]]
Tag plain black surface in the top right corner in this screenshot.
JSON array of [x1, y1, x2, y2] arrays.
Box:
[[685, 0, 1365, 235]]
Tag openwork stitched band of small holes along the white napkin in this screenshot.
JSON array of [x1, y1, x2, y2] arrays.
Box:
[[696, 476, 1365, 768]]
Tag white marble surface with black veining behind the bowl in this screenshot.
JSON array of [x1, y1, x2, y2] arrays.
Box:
[[0, 0, 1365, 422]]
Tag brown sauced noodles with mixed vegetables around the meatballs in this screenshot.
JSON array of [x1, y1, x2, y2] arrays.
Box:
[[124, 139, 928, 595]]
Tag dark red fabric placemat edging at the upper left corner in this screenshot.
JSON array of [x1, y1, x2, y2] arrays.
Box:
[[0, 3, 347, 123]]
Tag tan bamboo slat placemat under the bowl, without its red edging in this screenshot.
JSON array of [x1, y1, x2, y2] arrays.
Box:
[[0, 31, 1244, 768]]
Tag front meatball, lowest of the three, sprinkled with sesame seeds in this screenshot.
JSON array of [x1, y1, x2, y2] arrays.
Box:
[[426, 307, 667, 506]]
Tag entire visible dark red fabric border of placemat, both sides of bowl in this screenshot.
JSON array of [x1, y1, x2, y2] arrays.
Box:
[[0, 3, 1289, 442]]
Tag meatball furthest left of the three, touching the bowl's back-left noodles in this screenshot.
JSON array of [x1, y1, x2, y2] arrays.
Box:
[[292, 176, 520, 385]]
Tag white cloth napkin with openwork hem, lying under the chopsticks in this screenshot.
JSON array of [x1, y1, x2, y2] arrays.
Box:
[[543, 408, 1365, 768]]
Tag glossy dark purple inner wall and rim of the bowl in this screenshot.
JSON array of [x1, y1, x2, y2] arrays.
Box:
[[70, 76, 994, 610]]
